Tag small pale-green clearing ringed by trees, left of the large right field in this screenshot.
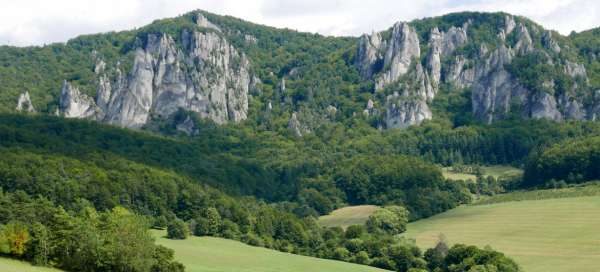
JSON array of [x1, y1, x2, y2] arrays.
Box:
[[319, 205, 378, 228]]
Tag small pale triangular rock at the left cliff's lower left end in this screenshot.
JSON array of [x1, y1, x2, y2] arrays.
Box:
[[59, 81, 101, 119]]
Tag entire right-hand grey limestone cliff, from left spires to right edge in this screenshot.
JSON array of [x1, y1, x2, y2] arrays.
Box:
[[355, 15, 600, 128]]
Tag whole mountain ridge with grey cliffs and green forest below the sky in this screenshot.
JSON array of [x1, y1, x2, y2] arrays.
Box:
[[0, 10, 600, 132]]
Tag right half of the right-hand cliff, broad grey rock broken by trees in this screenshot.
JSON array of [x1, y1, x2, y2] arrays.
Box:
[[472, 35, 590, 123]]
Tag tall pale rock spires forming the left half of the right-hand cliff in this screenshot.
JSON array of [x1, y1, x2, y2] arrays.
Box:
[[355, 21, 474, 128]]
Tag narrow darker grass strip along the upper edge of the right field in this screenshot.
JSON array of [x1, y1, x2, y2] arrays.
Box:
[[473, 182, 600, 205]]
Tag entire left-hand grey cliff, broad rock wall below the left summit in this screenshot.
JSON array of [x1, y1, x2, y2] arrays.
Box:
[[61, 14, 253, 128]]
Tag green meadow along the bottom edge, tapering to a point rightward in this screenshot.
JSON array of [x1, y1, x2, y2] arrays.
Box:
[[152, 231, 385, 272]]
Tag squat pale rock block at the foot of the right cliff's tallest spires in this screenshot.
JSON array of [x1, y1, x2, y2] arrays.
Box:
[[385, 93, 432, 129]]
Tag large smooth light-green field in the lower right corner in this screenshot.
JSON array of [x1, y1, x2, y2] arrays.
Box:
[[405, 196, 600, 272]]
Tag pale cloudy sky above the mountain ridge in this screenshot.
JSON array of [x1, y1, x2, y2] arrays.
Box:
[[0, 0, 600, 46]]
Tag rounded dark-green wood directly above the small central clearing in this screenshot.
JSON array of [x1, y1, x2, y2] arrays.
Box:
[[335, 156, 469, 218]]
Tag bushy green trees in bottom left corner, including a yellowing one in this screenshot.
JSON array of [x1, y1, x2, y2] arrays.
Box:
[[0, 191, 181, 271]]
